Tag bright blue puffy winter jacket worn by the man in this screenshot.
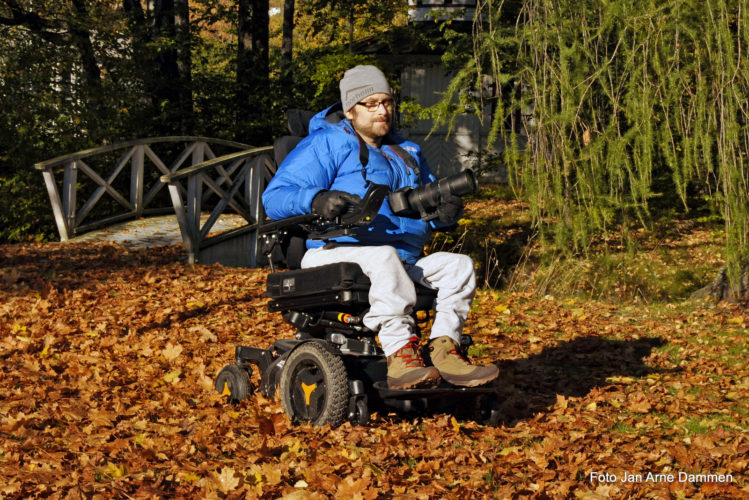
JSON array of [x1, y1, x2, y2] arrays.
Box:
[[263, 106, 442, 264]]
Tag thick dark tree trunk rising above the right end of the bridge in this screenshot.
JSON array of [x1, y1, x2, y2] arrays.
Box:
[[236, 0, 270, 143]]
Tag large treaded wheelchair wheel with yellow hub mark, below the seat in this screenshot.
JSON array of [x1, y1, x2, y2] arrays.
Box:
[[280, 342, 349, 427]]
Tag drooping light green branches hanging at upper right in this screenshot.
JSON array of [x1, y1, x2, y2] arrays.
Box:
[[444, 0, 749, 292]]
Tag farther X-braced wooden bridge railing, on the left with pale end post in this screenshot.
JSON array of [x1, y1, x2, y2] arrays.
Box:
[[34, 136, 252, 241]]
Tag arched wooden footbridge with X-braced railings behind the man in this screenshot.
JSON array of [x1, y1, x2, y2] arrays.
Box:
[[35, 136, 276, 267]]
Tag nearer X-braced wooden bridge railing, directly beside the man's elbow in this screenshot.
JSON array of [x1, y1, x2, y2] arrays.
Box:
[[161, 146, 276, 267]]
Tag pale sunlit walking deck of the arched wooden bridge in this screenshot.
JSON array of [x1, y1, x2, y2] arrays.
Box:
[[68, 213, 247, 248]]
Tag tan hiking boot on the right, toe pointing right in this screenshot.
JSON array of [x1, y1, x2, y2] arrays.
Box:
[[428, 337, 499, 387]]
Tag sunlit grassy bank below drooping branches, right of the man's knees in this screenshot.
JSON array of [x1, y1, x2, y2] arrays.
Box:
[[436, 185, 724, 303]]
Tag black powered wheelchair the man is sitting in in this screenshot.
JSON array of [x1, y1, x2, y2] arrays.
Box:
[[215, 112, 499, 426]]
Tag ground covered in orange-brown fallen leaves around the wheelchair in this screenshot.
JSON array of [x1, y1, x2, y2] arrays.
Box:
[[0, 235, 749, 499]]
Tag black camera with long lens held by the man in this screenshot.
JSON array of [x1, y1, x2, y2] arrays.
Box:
[[388, 170, 478, 221]]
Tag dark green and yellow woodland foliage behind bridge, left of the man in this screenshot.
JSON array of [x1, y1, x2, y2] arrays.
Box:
[[0, 1, 405, 241]]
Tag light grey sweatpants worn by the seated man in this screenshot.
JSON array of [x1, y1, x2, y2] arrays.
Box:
[[302, 245, 476, 356]]
